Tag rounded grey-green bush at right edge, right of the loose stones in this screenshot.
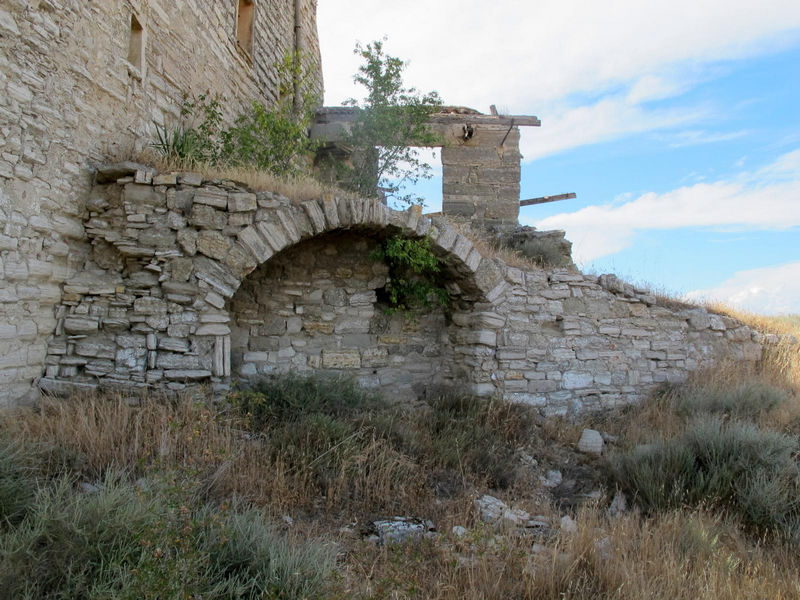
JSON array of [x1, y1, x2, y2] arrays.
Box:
[[609, 416, 800, 533]]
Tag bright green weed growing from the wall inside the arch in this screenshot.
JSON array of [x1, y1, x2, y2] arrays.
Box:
[[372, 236, 450, 315]]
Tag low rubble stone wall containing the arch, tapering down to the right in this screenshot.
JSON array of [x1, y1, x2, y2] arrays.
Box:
[[40, 169, 763, 413]]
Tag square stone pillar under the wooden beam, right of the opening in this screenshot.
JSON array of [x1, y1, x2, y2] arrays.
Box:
[[442, 124, 521, 225]]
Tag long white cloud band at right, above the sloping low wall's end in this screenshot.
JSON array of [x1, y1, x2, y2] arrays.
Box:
[[520, 150, 800, 264]]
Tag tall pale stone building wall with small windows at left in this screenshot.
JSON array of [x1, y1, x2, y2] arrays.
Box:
[[0, 0, 322, 405]]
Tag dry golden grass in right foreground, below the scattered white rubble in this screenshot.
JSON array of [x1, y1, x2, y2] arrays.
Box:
[[337, 506, 800, 600]]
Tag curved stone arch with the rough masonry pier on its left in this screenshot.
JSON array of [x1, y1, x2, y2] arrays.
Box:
[[42, 170, 506, 398]]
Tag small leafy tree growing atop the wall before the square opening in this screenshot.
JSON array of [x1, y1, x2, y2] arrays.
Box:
[[338, 38, 442, 205]]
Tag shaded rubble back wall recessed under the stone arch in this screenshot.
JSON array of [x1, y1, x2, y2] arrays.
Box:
[[229, 232, 455, 399]]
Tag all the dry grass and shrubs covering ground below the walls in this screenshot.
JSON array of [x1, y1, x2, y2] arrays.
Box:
[[0, 318, 800, 600]]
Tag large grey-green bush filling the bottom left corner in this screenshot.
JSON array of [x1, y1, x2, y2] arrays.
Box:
[[0, 474, 333, 599]]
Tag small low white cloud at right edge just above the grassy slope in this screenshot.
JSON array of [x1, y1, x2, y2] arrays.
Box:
[[686, 261, 800, 314]]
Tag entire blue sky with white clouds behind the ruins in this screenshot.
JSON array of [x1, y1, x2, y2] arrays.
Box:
[[319, 0, 800, 314]]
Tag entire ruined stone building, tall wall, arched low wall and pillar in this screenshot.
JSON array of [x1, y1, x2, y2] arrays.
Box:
[[0, 0, 763, 413]]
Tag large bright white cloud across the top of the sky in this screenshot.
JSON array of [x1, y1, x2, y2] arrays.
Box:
[[318, 0, 800, 160]]
